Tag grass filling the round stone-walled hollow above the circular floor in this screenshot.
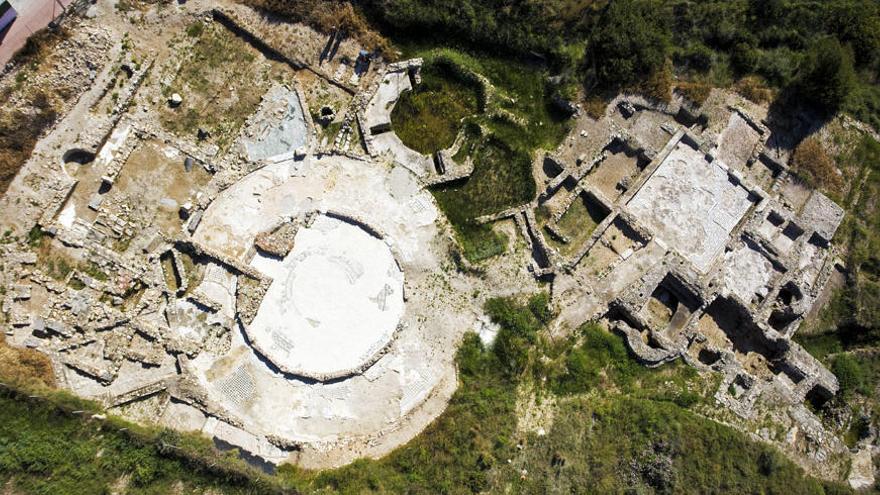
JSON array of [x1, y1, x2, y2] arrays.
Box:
[[391, 64, 479, 155]]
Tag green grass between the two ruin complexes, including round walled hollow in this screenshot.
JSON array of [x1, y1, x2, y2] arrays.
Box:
[[392, 46, 569, 262]]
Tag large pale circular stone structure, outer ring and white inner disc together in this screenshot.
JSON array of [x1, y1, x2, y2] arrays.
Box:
[[186, 150, 479, 469]]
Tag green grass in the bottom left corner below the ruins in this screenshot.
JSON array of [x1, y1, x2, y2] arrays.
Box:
[[0, 392, 277, 495]]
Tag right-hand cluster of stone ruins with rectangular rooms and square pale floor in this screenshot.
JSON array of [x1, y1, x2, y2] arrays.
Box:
[[480, 97, 843, 464]]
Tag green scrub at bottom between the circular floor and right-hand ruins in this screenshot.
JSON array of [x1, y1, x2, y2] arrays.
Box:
[[300, 295, 846, 494]]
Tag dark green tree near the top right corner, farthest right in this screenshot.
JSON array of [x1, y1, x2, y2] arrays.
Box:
[[796, 37, 856, 114]]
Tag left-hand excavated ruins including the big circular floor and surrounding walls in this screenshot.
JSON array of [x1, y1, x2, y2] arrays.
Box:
[[0, 6, 478, 467]]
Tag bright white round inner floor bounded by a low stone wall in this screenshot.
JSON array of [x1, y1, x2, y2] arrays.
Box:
[[246, 214, 404, 381]]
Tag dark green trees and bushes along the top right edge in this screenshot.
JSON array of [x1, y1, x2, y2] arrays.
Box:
[[364, 0, 880, 127]]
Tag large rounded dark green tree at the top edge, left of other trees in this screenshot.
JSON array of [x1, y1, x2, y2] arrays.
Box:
[[586, 0, 669, 89]]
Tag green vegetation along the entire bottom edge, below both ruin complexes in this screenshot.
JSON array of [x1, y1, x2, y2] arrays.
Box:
[[0, 294, 848, 494]]
